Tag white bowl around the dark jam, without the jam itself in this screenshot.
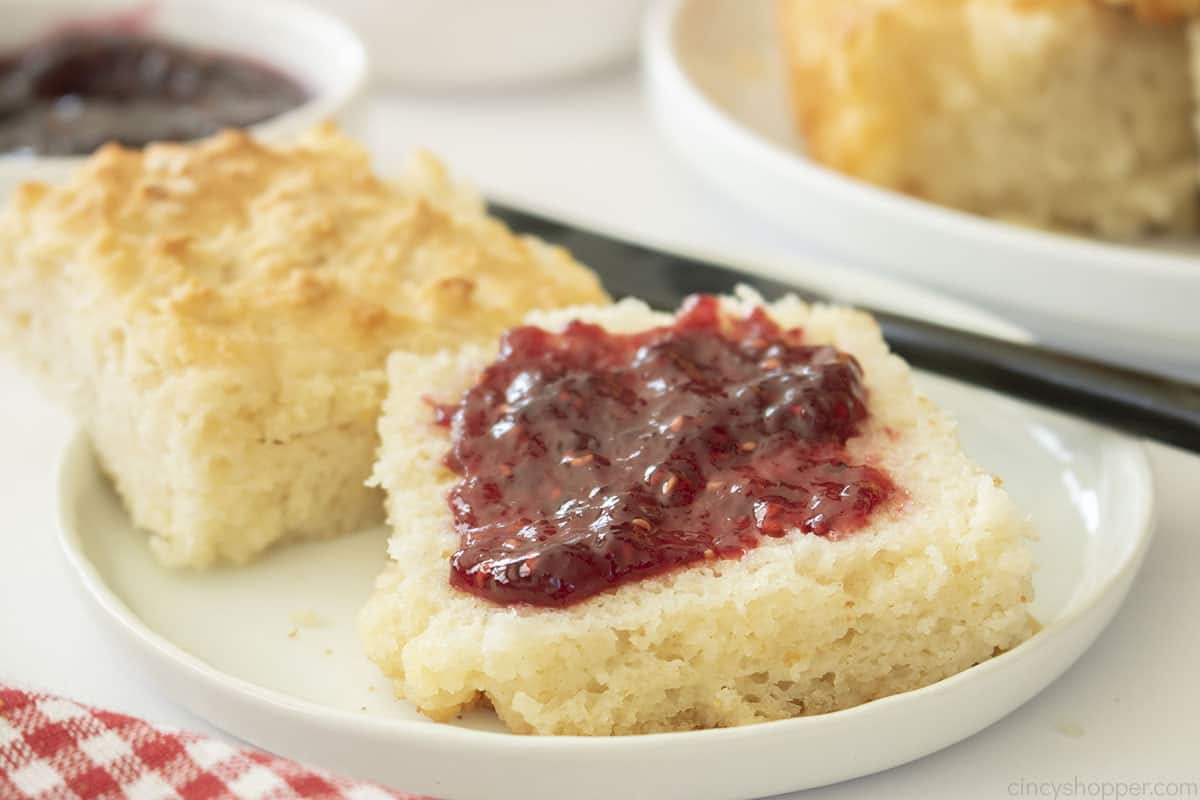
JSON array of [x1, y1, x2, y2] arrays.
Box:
[[0, 0, 367, 187]]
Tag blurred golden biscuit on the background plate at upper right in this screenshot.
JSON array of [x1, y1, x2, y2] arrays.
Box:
[[779, 0, 1198, 239]]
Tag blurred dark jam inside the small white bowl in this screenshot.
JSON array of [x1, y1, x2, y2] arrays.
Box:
[[0, 28, 308, 156]]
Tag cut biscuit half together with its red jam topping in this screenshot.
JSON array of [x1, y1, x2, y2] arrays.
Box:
[[360, 294, 1036, 735]]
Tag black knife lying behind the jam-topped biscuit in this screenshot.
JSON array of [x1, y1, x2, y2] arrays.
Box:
[[490, 203, 1200, 452]]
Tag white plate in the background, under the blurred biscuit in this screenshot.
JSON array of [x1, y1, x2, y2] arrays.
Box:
[[643, 0, 1200, 379]]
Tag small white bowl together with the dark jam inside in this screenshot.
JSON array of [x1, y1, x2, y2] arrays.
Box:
[[0, 0, 366, 181]]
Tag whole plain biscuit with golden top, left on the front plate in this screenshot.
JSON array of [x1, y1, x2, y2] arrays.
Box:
[[0, 127, 604, 567]]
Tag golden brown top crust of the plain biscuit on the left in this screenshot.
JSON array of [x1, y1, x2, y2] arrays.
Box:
[[0, 126, 604, 372]]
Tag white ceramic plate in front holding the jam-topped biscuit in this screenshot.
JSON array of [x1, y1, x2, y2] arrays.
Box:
[[60, 272, 1152, 800]]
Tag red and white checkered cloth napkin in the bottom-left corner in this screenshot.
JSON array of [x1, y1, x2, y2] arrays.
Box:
[[0, 682, 415, 800]]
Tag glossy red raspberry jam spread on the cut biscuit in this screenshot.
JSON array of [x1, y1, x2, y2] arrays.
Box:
[[436, 296, 895, 607]]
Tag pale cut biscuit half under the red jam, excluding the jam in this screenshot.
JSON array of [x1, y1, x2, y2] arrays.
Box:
[[360, 294, 1037, 735]]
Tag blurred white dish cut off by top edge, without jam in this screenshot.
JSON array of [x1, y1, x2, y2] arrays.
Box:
[[304, 0, 648, 89]]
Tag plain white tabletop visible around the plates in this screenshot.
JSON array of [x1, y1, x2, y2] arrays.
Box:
[[0, 70, 1200, 800]]
